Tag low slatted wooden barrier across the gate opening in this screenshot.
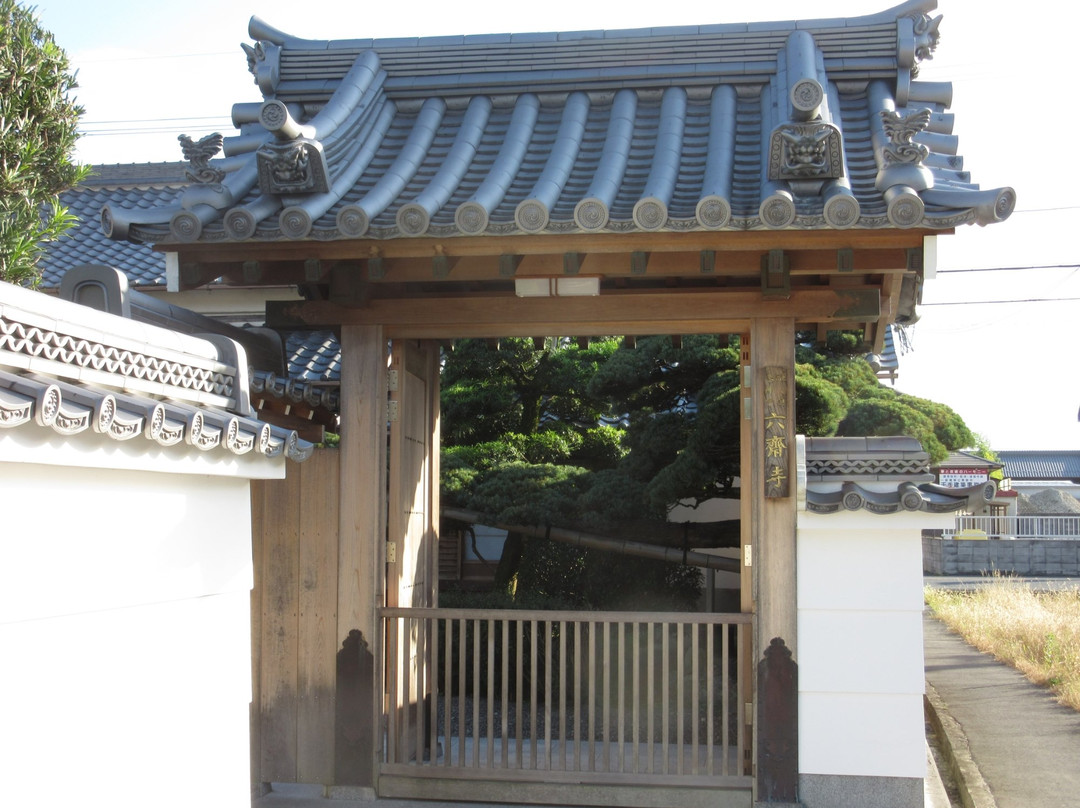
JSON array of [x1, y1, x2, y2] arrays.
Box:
[[381, 608, 752, 784]]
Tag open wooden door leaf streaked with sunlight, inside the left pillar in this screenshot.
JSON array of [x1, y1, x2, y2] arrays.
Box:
[[387, 340, 438, 760]]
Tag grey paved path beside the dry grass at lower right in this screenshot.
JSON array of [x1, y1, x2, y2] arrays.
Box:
[[923, 614, 1080, 808]]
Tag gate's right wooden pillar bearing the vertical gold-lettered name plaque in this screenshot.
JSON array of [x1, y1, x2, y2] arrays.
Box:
[[742, 318, 798, 803]]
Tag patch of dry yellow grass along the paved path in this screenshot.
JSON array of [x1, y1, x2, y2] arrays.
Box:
[[926, 578, 1080, 710]]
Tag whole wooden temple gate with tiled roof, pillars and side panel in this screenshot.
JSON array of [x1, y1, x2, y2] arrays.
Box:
[[126, 7, 1015, 805]]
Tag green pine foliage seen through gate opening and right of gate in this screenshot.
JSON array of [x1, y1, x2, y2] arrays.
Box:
[[443, 334, 975, 607]]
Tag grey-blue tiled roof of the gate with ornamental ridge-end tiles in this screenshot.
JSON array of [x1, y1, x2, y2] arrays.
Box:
[[103, 0, 1015, 243]]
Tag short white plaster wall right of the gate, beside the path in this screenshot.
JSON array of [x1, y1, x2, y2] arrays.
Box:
[[797, 511, 951, 778]]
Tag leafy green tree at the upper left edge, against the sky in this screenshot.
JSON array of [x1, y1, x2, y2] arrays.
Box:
[[0, 0, 89, 286]]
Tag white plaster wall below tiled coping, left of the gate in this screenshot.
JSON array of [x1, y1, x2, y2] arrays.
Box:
[[0, 458, 252, 808]]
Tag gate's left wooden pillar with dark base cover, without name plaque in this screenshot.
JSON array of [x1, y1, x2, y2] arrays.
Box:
[[335, 325, 387, 789]]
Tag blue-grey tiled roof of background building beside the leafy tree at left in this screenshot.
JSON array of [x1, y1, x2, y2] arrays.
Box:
[[40, 163, 188, 288]]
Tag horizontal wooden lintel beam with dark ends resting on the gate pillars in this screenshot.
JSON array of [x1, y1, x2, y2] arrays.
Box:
[[267, 286, 880, 339]]
